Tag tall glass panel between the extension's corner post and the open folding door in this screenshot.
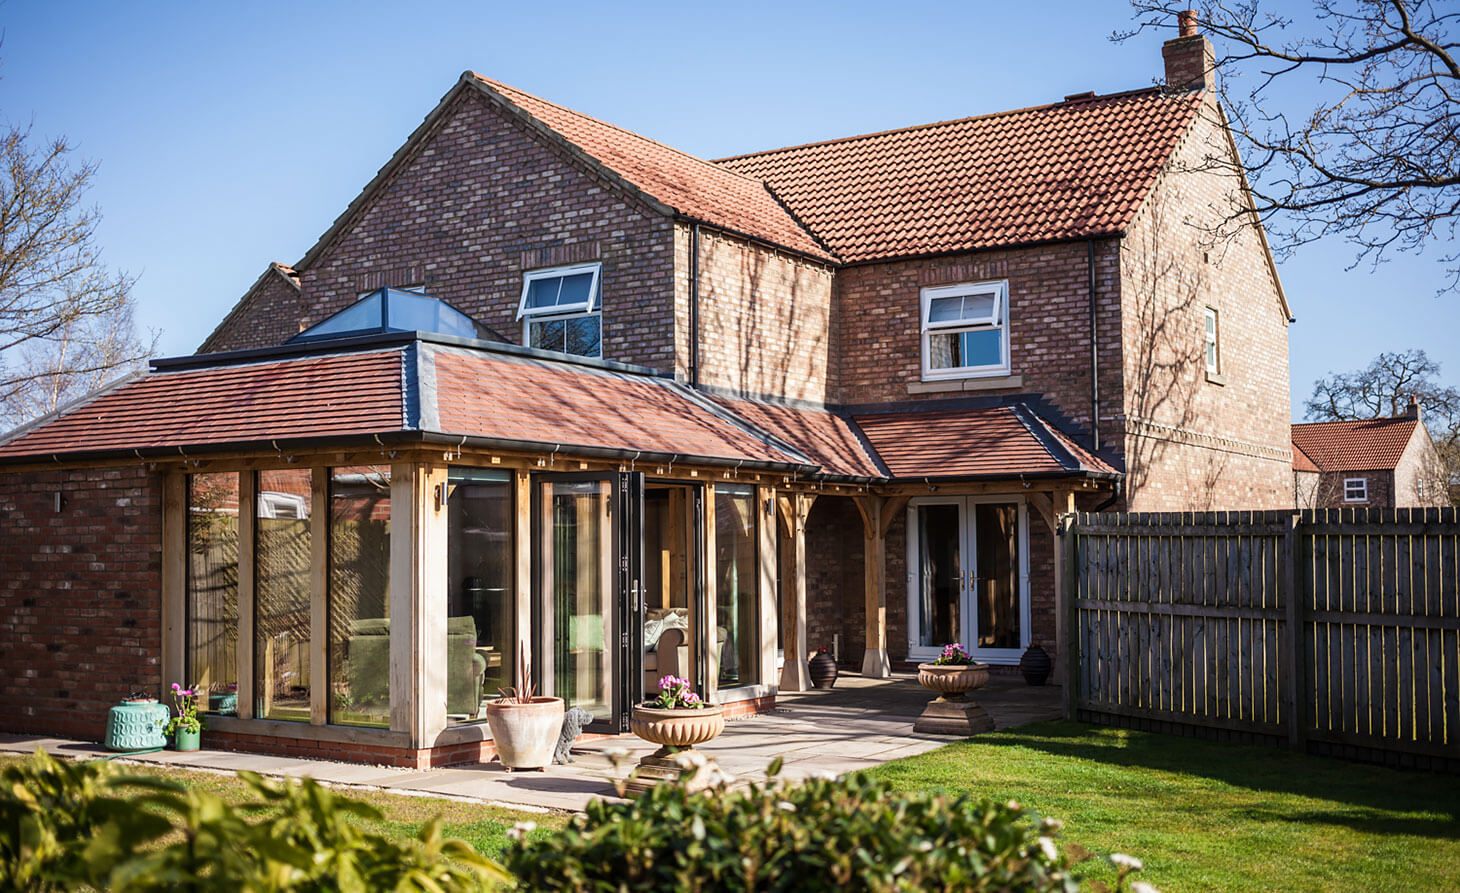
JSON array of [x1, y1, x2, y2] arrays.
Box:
[[445, 468, 517, 722]]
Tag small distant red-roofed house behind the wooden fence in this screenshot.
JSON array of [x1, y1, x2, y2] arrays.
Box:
[[1292, 397, 1450, 508]]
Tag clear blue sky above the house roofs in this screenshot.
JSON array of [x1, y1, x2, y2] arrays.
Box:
[[0, 0, 1460, 414]]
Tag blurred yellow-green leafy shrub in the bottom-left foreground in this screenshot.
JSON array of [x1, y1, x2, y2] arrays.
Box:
[[0, 753, 510, 893]]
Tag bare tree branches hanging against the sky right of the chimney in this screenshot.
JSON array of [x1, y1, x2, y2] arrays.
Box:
[[1114, 0, 1460, 290]]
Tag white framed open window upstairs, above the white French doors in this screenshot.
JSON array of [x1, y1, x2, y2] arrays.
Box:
[[923, 280, 1009, 381]]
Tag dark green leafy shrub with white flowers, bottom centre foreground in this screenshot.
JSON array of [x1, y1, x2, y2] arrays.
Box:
[[507, 760, 1124, 892]]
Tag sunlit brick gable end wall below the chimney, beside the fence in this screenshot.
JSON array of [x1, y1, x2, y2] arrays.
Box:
[[1110, 97, 1294, 511]]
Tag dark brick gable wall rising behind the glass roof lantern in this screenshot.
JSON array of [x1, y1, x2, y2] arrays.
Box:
[[202, 89, 675, 369]]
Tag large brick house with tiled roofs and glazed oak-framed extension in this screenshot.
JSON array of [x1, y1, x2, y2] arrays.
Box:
[[0, 16, 1294, 766]]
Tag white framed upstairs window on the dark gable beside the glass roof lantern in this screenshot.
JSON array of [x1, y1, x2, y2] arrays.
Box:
[[517, 264, 603, 357]]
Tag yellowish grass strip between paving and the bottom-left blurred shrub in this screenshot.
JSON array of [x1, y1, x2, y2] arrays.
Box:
[[0, 756, 568, 859]]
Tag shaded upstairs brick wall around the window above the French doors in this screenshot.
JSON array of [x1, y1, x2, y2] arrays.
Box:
[[837, 241, 1121, 441]]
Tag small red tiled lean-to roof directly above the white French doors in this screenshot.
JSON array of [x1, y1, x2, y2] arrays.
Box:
[[853, 404, 1117, 479]]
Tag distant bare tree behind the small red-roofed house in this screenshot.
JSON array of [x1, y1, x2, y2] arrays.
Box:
[[1304, 350, 1460, 501]]
